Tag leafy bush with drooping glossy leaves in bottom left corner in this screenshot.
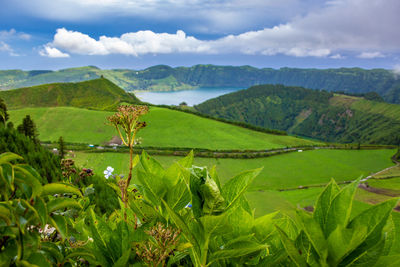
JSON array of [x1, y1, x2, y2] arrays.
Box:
[[0, 152, 88, 266]]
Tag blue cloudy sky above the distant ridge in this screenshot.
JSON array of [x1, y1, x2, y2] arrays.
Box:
[[0, 0, 400, 72]]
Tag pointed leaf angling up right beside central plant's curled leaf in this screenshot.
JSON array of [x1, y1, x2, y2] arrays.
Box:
[[222, 168, 262, 209]]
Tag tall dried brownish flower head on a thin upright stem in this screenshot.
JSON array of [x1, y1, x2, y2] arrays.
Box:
[[107, 105, 149, 224]]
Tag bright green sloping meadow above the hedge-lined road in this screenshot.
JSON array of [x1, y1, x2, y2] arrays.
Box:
[[9, 107, 318, 150]]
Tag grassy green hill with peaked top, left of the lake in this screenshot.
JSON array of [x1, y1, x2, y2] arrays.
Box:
[[0, 78, 140, 110]]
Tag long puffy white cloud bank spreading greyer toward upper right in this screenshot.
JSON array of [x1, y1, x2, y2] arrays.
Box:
[[39, 0, 400, 59]]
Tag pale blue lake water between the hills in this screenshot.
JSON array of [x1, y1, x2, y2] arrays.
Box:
[[135, 87, 243, 106]]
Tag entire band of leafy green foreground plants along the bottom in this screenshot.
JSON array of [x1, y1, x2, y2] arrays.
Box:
[[0, 152, 399, 267]]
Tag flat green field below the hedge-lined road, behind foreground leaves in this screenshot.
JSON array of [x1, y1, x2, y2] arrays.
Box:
[[75, 150, 395, 215]]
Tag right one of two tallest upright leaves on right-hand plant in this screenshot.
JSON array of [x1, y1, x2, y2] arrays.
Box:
[[324, 179, 359, 237]]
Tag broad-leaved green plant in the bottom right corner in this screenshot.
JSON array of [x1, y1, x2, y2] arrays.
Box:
[[275, 180, 400, 266]]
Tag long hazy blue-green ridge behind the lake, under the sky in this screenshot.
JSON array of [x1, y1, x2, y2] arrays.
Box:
[[0, 65, 400, 103]]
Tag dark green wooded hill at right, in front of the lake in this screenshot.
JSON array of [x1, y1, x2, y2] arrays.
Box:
[[195, 85, 400, 144]]
